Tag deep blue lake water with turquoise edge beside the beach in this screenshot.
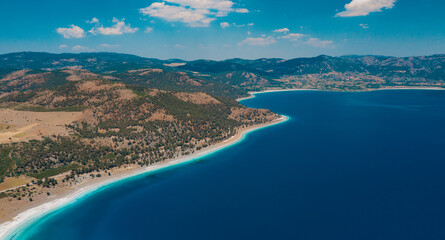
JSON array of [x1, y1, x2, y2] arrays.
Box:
[[8, 90, 445, 240]]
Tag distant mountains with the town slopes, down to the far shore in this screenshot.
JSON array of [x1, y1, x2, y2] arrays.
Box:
[[0, 52, 445, 94]]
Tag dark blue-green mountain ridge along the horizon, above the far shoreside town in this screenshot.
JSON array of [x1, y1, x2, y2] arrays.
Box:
[[0, 52, 445, 75]]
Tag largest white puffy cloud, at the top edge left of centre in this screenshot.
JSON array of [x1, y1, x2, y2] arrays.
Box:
[[140, 0, 249, 27]]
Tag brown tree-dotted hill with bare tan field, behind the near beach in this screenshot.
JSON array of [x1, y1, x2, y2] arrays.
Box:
[[0, 79, 279, 186]]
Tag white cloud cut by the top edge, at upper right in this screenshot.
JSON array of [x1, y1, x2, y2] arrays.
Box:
[[336, 0, 397, 17]]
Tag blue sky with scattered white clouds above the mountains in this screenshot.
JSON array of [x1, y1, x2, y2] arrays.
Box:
[[0, 0, 445, 60]]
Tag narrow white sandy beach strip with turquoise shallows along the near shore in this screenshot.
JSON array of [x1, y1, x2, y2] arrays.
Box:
[[0, 116, 289, 239]]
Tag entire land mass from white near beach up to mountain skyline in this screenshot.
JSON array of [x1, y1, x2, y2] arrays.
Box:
[[0, 52, 445, 237]]
